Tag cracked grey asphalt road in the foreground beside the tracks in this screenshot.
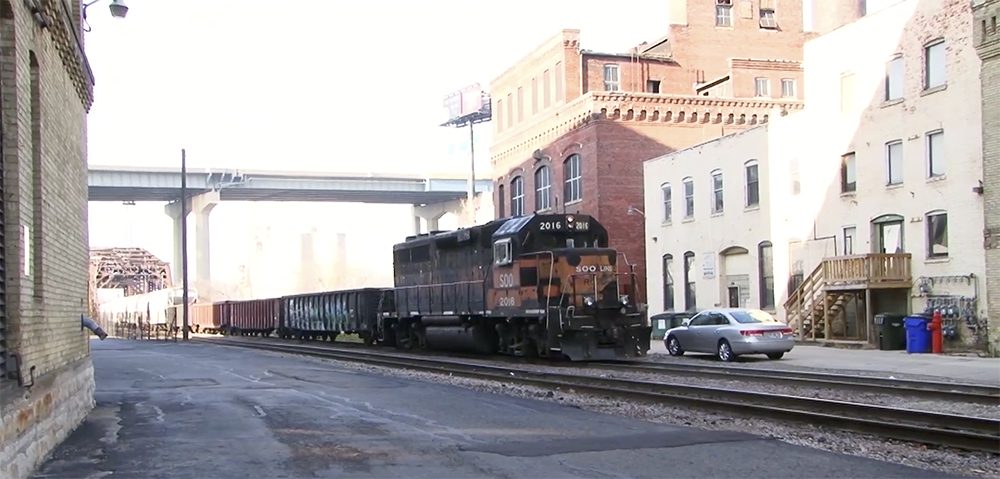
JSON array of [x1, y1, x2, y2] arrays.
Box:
[[35, 339, 972, 479]]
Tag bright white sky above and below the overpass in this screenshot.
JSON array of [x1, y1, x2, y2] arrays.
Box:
[[85, 0, 669, 289]]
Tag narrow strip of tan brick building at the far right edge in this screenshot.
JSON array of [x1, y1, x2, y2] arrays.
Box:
[[972, 0, 1000, 356]]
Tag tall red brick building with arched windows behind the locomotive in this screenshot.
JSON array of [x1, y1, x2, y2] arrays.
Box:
[[490, 0, 828, 300]]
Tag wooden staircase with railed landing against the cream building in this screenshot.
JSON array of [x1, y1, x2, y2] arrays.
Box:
[[785, 253, 912, 340]]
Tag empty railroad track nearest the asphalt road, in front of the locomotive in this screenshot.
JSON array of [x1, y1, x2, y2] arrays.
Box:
[[195, 339, 1000, 454]]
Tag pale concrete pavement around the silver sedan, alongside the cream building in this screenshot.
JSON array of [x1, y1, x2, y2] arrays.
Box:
[[649, 341, 1000, 386]]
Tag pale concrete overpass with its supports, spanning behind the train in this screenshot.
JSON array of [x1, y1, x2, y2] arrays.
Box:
[[88, 166, 493, 289]]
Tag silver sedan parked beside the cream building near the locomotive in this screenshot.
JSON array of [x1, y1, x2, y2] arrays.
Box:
[[663, 309, 795, 361]]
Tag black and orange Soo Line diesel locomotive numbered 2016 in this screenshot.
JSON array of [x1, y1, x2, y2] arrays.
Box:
[[379, 214, 652, 360]]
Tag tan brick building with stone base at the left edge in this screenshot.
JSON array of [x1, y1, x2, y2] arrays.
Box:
[[0, 0, 94, 479]]
